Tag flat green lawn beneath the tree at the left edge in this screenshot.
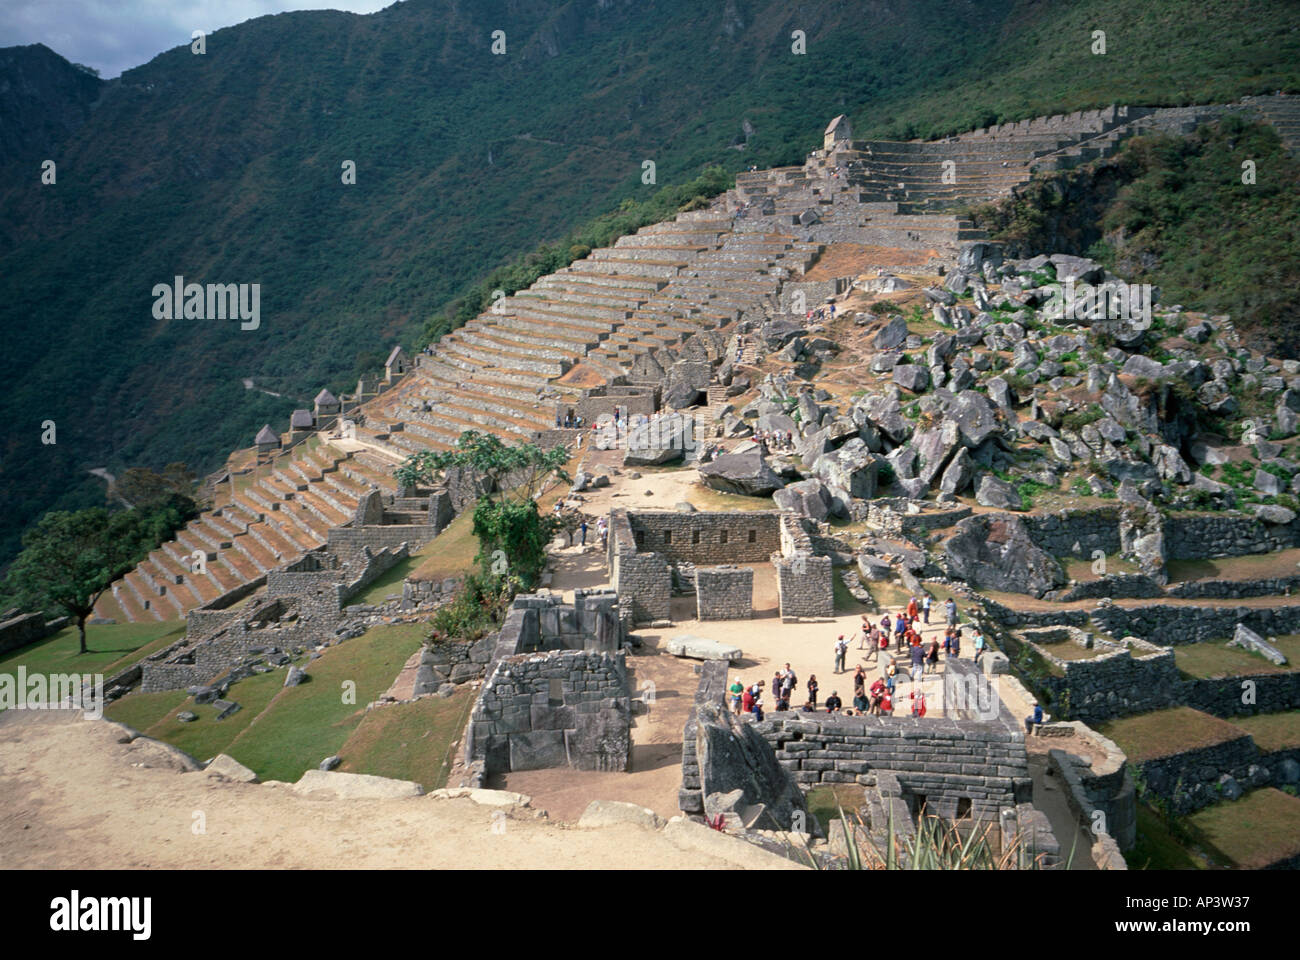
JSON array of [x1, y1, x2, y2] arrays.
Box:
[[0, 620, 185, 680]]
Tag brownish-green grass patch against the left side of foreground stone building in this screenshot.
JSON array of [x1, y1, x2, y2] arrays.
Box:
[[338, 689, 475, 790]]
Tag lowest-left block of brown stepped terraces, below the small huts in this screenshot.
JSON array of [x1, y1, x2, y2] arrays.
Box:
[[96, 442, 397, 620]]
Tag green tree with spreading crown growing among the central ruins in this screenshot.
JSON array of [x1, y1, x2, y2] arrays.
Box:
[[394, 431, 569, 592]]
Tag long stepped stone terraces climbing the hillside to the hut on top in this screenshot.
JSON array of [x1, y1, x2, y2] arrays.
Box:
[[100, 98, 1296, 620]]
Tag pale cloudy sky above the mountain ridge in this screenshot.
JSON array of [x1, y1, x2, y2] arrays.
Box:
[[0, 0, 394, 79]]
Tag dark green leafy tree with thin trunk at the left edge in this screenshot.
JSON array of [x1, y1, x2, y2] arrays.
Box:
[[5, 507, 152, 653]]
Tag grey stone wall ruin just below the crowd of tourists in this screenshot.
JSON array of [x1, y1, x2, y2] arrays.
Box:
[[679, 661, 1061, 868]]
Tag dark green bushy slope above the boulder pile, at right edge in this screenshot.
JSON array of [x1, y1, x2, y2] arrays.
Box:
[[972, 116, 1300, 359]]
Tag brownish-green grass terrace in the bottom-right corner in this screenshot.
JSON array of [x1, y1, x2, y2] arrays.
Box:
[[1187, 787, 1300, 870]]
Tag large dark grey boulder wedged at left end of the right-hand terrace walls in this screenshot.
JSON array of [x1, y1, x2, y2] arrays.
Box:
[[944, 514, 1066, 597]]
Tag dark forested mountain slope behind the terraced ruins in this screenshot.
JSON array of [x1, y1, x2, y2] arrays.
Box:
[[0, 0, 1300, 562]]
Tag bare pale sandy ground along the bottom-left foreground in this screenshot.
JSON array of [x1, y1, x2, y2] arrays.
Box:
[[0, 710, 793, 869]]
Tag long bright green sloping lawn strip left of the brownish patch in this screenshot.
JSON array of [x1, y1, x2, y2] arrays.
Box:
[[219, 623, 426, 783]]
